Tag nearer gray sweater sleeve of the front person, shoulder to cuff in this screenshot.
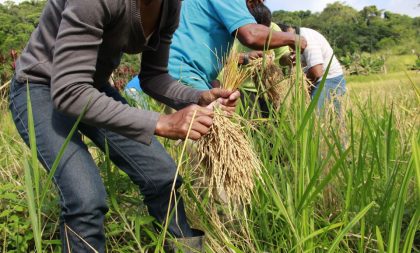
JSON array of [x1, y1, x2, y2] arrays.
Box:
[[51, 0, 159, 144]]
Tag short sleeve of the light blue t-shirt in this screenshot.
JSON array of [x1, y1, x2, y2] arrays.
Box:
[[210, 0, 257, 34]]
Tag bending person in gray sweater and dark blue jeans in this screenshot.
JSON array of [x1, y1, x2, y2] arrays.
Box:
[[10, 0, 239, 252]]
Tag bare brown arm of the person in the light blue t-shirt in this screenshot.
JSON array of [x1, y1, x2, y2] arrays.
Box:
[[237, 24, 306, 50]]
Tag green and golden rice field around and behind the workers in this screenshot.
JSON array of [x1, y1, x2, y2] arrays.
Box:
[[0, 68, 420, 253]]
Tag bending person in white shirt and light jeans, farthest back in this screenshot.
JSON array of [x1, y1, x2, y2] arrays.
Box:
[[278, 24, 346, 114]]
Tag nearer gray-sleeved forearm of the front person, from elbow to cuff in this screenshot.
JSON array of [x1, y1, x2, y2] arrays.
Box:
[[51, 83, 159, 144]]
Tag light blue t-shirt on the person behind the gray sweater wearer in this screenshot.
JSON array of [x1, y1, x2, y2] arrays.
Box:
[[169, 0, 256, 90]]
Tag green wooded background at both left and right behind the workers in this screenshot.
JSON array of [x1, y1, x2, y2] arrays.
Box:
[[0, 0, 420, 56]]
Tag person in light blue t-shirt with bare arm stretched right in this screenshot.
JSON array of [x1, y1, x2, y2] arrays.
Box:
[[169, 0, 306, 90]]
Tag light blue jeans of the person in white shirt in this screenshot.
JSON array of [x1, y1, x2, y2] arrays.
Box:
[[311, 75, 346, 115]]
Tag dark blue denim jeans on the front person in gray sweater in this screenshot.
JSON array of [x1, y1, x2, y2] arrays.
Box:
[[10, 79, 193, 252]]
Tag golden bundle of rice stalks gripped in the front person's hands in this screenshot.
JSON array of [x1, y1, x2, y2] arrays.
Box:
[[197, 50, 261, 204]]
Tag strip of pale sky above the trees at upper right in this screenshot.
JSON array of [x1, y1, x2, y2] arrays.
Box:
[[265, 0, 420, 17]]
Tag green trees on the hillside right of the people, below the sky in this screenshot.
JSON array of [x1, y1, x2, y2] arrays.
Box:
[[273, 2, 420, 56]]
